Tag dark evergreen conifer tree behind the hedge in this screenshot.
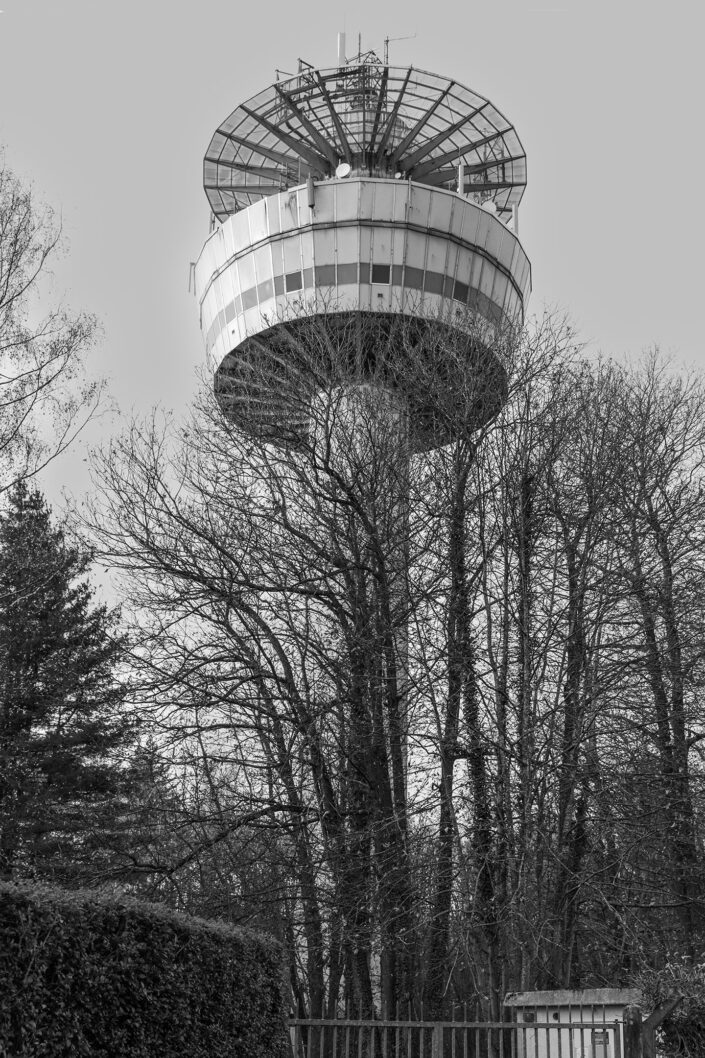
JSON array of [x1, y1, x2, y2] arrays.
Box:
[[0, 482, 135, 884]]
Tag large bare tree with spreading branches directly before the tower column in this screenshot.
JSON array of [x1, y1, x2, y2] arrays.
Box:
[[85, 306, 527, 1014]]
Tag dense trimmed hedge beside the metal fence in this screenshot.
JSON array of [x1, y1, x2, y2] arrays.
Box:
[[0, 882, 287, 1058]]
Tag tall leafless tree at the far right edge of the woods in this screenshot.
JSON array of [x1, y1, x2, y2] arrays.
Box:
[[597, 353, 705, 960]]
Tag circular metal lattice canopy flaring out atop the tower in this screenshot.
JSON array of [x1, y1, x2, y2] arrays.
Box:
[[203, 54, 526, 220]]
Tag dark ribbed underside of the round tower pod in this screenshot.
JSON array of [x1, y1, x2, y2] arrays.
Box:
[[215, 311, 510, 452]]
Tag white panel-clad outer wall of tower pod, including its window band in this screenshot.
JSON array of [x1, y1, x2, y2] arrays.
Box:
[[196, 178, 530, 357]]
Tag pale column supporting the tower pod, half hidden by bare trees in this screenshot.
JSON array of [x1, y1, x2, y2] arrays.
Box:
[[311, 383, 413, 1019]]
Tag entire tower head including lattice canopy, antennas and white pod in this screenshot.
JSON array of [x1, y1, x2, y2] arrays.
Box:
[[195, 34, 530, 451]]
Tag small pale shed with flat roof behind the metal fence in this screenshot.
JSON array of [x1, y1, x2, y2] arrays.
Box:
[[504, 988, 641, 1058]]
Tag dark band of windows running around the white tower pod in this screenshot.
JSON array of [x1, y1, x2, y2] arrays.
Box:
[[205, 261, 519, 352]]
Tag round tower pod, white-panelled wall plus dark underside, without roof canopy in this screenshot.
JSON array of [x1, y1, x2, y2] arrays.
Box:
[[196, 178, 530, 450]]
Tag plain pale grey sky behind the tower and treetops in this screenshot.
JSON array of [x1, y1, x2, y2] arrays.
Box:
[[0, 0, 705, 498]]
